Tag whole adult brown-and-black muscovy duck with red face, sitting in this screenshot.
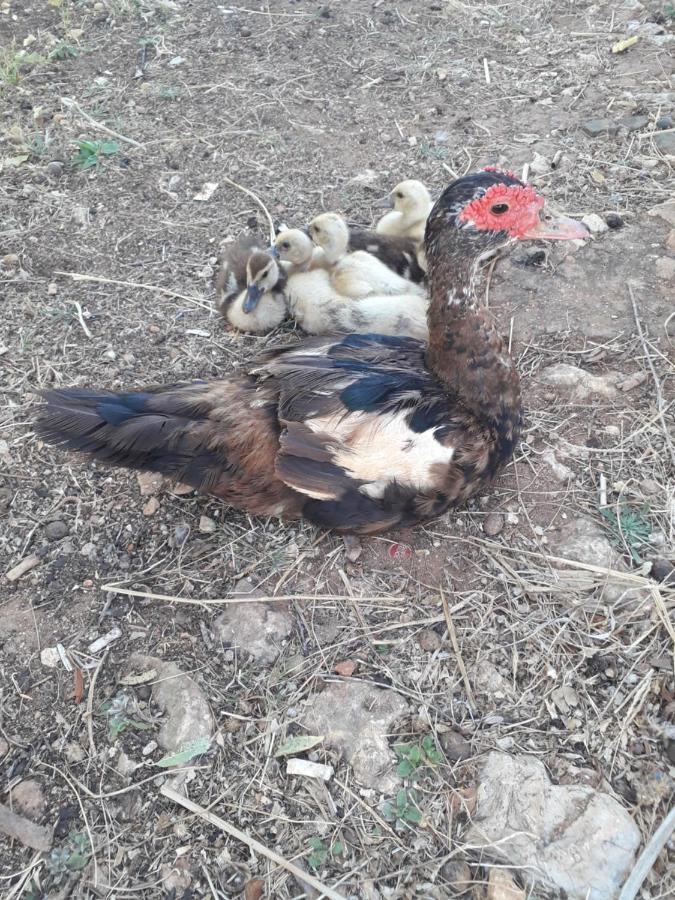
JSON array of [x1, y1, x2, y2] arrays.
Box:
[[37, 171, 586, 534]]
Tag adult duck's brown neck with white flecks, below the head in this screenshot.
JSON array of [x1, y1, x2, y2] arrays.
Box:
[[427, 247, 520, 452]]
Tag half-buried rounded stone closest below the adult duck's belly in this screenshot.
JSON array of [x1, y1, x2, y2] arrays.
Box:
[[213, 578, 293, 665]]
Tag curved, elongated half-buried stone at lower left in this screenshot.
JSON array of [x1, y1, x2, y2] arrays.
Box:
[[127, 653, 214, 751]]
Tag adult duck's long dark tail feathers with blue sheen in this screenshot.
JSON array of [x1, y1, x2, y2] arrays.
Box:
[[35, 383, 226, 489]]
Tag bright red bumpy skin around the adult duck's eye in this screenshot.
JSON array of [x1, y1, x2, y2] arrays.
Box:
[[458, 184, 544, 240]]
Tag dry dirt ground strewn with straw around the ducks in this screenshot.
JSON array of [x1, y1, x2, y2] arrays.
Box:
[[0, 0, 675, 900]]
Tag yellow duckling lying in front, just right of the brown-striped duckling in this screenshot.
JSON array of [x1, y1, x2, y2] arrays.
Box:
[[272, 228, 428, 340]]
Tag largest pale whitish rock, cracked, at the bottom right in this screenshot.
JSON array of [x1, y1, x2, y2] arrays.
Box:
[[466, 751, 640, 900]]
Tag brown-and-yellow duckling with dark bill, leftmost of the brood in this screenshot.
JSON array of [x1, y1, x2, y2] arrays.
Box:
[[216, 249, 288, 334]]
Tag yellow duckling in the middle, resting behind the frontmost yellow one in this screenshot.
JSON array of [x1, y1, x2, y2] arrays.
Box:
[[308, 213, 426, 299]]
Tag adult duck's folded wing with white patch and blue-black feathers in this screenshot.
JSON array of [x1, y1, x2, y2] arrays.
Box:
[[257, 335, 460, 510]]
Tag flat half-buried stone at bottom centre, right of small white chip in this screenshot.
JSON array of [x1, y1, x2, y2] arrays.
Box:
[[301, 681, 408, 794]]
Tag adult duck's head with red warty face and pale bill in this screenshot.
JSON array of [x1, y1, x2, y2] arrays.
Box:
[[425, 168, 588, 271]]
